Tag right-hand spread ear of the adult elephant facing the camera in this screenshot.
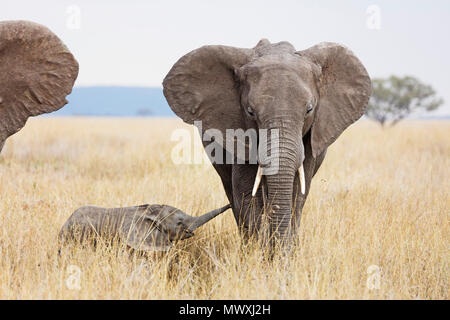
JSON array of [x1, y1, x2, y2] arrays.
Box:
[[297, 42, 372, 158]]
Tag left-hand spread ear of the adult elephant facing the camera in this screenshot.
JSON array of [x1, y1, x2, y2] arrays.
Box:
[[163, 46, 253, 147]]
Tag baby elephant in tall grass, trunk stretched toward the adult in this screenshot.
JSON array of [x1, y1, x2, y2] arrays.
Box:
[[59, 204, 231, 251]]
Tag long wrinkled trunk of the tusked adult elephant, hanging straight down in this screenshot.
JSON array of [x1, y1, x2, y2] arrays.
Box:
[[260, 121, 305, 244]]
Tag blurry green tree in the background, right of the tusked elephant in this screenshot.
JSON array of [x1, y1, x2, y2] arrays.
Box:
[[366, 76, 444, 126]]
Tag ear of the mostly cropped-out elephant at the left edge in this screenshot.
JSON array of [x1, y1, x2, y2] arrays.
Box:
[[0, 21, 78, 150]]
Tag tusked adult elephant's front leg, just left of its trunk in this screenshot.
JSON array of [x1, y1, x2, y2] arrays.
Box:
[[232, 164, 263, 240]]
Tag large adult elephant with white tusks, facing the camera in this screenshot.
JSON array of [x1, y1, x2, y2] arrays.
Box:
[[163, 39, 371, 244]]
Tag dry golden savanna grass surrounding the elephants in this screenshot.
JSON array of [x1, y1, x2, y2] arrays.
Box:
[[0, 118, 450, 299]]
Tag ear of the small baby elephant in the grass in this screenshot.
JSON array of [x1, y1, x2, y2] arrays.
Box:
[[120, 214, 172, 251]]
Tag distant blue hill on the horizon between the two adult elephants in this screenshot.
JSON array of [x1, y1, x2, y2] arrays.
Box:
[[51, 87, 175, 117]]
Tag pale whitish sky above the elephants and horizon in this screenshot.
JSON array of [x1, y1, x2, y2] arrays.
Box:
[[0, 0, 450, 115]]
